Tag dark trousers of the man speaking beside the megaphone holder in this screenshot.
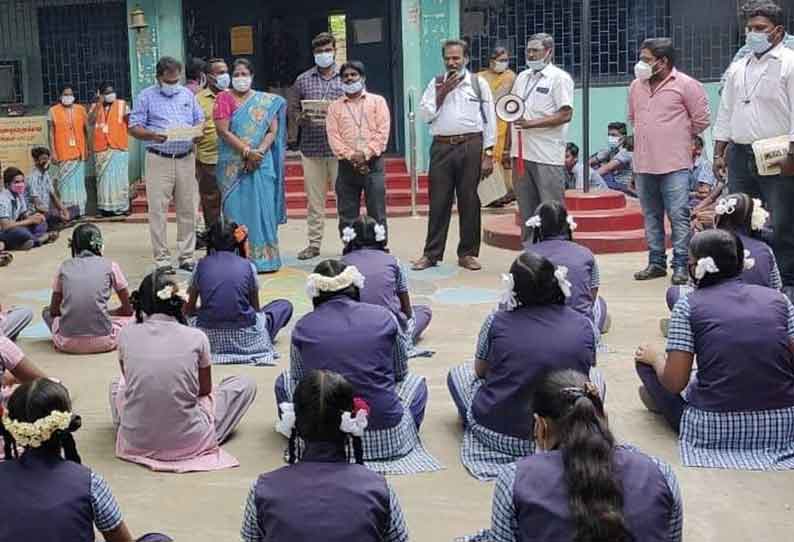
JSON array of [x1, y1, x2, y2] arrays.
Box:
[[424, 134, 482, 262]]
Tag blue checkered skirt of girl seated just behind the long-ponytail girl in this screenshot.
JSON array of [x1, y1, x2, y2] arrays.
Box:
[[450, 364, 535, 480]]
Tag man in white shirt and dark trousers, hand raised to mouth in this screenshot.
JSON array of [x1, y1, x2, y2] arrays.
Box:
[[413, 40, 496, 271]]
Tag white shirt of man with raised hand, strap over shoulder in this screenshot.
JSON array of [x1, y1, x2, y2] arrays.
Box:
[[421, 70, 496, 149]]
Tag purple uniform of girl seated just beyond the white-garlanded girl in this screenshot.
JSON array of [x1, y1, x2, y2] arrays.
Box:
[[342, 248, 433, 347]]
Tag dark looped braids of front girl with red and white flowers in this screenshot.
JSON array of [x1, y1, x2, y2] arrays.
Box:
[[289, 370, 364, 465]]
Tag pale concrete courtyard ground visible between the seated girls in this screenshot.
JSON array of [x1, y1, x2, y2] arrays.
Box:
[[0, 218, 794, 542]]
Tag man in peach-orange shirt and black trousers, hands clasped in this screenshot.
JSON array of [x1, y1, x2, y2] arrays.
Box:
[[326, 60, 391, 235]]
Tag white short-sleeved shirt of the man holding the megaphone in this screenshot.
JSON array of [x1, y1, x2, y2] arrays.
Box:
[[510, 64, 574, 166]]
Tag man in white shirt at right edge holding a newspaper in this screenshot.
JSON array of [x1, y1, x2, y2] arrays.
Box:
[[714, 2, 794, 298]]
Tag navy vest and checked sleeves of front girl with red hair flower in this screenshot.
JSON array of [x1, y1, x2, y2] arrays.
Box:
[[240, 442, 408, 542]]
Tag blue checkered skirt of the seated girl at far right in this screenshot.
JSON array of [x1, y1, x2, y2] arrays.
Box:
[[678, 406, 794, 470]]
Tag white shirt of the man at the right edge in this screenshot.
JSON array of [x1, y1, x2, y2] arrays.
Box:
[[714, 43, 794, 145]]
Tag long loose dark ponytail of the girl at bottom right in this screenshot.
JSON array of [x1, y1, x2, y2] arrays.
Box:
[[533, 370, 634, 542]]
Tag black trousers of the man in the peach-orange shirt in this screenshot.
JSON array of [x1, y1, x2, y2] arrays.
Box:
[[336, 156, 389, 237]]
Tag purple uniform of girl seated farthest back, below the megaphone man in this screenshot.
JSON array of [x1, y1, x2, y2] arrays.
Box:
[[524, 235, 607, 331]]
